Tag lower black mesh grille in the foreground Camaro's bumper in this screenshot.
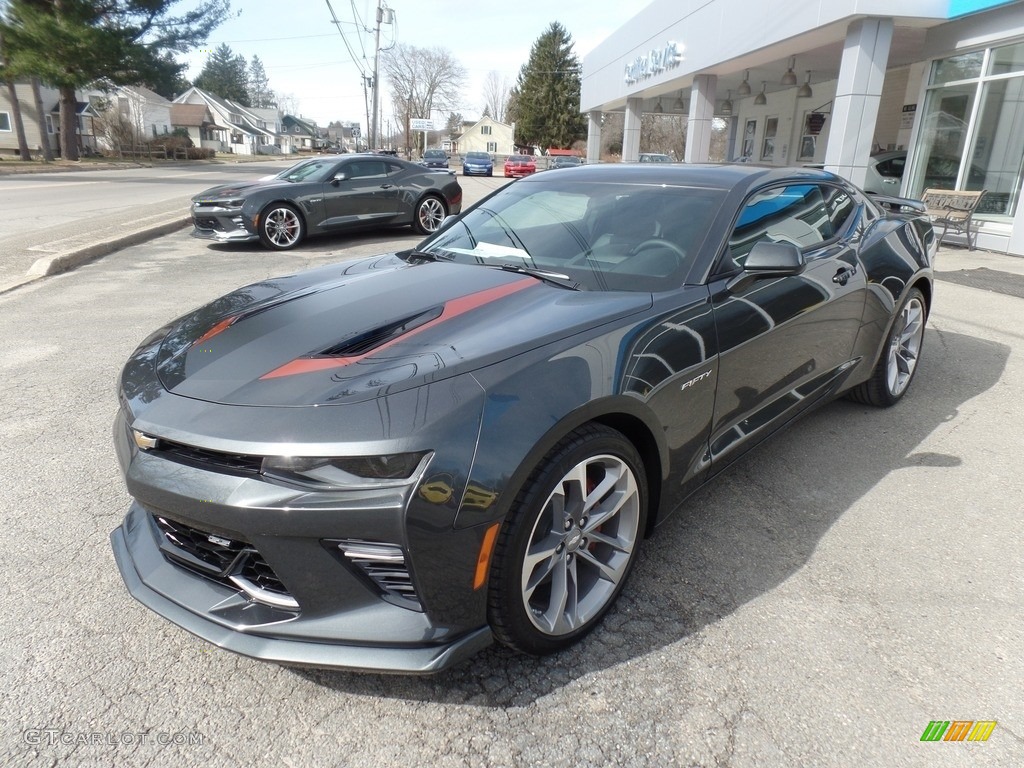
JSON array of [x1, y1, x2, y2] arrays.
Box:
[[153, 514, 299, 609]]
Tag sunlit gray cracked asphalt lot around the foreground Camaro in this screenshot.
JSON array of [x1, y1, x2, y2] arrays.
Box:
[[0, 207, 1024, 768]]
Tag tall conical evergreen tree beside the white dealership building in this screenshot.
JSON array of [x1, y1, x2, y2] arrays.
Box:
[[509, 22, 587, 148]]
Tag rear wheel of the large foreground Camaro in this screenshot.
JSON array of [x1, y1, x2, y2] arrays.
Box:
[[850, 288, 928, 408]]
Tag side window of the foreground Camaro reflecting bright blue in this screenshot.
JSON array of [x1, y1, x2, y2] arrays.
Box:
[[725, 184, 831, 267]]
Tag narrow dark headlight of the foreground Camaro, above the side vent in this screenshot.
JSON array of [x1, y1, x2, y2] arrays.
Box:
[[262, 451, 430, 489]]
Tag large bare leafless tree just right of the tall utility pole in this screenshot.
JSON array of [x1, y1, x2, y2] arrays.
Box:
[[381, 43, 466, 154]]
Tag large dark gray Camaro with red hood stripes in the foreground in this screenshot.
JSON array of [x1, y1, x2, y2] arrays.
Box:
[[111, 165, 936, 673]]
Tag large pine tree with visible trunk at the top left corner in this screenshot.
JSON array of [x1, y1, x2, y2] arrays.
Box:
[[0, 0, 230, 160]]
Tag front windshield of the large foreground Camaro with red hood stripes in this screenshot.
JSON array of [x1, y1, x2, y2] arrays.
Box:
[[418, 179, 724, 291]]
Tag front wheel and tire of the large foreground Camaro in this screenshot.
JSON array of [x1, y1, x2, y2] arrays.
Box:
[[487, 424, 647, 654]]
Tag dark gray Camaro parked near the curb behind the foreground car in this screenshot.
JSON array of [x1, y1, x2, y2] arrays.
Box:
[[191, 155, 462, 251]]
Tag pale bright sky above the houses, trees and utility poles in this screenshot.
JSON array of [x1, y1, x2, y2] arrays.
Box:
[[179, 0, 634, 131]]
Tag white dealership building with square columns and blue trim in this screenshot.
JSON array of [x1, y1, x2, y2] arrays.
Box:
[[581, 0, 1024, 256]]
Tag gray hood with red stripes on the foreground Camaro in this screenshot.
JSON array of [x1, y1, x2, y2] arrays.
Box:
[[148, 254, 651, 407]]
